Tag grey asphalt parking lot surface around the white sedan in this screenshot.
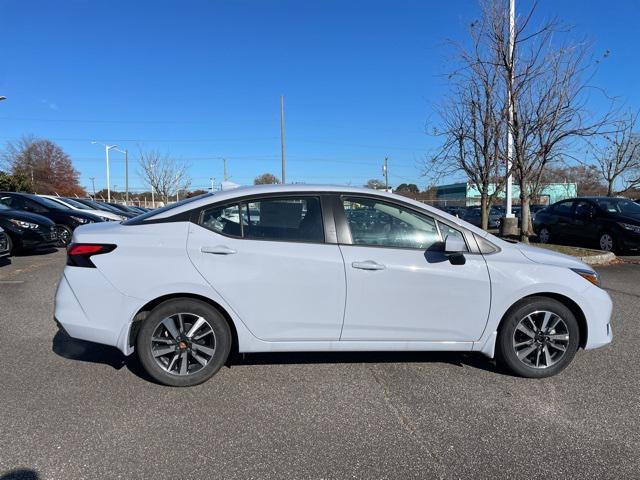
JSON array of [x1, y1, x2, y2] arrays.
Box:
[[0, 251, 640, 479]]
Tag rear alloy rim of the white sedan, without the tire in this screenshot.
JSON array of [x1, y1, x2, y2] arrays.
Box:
[[151, 313, 216, 375]]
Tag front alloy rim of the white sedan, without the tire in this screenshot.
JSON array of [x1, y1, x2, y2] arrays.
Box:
[[513, 310, 569, 369]]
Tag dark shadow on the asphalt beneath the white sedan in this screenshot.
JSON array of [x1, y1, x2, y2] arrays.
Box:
[[51, 331, 510, 382]]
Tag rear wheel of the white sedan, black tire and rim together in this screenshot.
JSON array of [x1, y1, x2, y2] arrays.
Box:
[[136, 298, 232, 387]]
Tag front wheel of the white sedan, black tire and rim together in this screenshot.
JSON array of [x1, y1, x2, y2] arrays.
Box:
[[496, 297, 580, 378]]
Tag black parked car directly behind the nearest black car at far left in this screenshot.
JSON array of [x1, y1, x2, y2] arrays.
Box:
[[0, 192, 102, 246]]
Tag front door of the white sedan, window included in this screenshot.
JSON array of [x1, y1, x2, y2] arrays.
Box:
[[340, 196, 491, 342]]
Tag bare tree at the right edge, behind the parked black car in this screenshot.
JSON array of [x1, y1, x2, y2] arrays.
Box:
[[592, 112, 640, 197]]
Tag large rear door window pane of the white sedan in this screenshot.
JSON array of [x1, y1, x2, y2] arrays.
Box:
[[242, 196, 324, 243]]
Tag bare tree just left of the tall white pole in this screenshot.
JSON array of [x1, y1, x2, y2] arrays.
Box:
[[422, 14, 506, 229]]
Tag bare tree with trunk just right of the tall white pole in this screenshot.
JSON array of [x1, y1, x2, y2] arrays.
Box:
[[483, 0, 609, 242]]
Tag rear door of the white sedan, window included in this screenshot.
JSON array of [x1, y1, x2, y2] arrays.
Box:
[[188, 195, 346, 341]]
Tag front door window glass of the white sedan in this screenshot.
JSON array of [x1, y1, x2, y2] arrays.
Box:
[[342, 197, 442, 250]]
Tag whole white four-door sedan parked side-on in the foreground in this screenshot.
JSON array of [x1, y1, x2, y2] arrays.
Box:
[[55, 185, 612, 386]]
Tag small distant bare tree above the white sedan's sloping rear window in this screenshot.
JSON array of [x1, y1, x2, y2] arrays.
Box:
[[138, 150, 191, 202]]
